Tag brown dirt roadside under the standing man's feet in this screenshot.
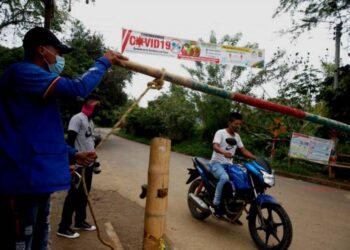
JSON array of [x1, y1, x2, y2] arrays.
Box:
[[51, 189, 144, 250]]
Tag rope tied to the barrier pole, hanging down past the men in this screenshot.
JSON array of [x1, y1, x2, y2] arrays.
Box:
[[81, 69, 165, 250]]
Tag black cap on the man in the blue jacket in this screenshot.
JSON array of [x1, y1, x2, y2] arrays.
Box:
[[23, 27, 73, 54]]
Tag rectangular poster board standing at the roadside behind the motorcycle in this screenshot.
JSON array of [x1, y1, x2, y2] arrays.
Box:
[[289, 133, 333, 165]]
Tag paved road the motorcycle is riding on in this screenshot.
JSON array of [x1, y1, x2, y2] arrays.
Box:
[[94, 132, 350, 250]]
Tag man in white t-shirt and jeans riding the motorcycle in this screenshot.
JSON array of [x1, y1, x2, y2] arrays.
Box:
[[209, 112, 256, 217]]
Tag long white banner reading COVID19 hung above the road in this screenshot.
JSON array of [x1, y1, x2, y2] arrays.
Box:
[[121, 29, 265, 68]]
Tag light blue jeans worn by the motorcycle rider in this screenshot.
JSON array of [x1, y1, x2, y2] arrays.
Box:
[[209, 162, 234, 206]]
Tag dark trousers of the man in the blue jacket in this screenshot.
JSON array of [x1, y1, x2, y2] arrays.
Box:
[[0, 194, 51, 250]]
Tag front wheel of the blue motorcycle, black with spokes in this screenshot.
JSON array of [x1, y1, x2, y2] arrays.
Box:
[[249, 203, 293, 250]]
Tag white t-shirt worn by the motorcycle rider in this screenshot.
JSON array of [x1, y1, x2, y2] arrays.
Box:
[[210, 128, 244, 164]]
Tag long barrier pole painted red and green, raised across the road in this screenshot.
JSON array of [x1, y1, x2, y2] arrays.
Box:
[[123, 61, 350, 132]]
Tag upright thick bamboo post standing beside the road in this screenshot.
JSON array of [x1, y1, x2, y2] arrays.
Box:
[[143, 137, 171, 250]]
